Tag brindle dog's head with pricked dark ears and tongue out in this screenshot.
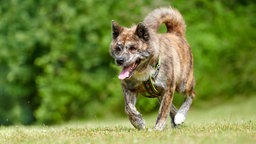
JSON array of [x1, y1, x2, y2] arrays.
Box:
[[110, 21, 153, 80]]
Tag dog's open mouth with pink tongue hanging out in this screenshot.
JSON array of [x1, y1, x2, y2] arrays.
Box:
[[118, 59, 141, 80]]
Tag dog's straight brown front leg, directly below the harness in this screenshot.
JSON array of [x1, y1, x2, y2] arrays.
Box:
[[155, 87, 175, 130]]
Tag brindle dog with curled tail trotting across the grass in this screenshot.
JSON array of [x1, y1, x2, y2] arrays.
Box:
[[110, 7, 195, 130]]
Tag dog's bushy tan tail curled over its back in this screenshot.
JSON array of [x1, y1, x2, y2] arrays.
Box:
[[143, 7, 186, 35]]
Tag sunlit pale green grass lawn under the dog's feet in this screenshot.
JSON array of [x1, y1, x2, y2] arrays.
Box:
[[0, 97, 256, 144]]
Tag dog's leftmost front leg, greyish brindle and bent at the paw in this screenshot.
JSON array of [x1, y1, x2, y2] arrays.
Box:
[[123, 87, 146, 129]]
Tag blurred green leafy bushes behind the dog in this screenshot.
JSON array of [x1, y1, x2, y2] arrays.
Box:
[[0, 0, 256, 125]]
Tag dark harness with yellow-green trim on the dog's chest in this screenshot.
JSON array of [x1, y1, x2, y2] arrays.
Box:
[[143, 57, 161, 98]]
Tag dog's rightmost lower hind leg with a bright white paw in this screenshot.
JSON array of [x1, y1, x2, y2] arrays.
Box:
[[174, 96, 193, 125]]
